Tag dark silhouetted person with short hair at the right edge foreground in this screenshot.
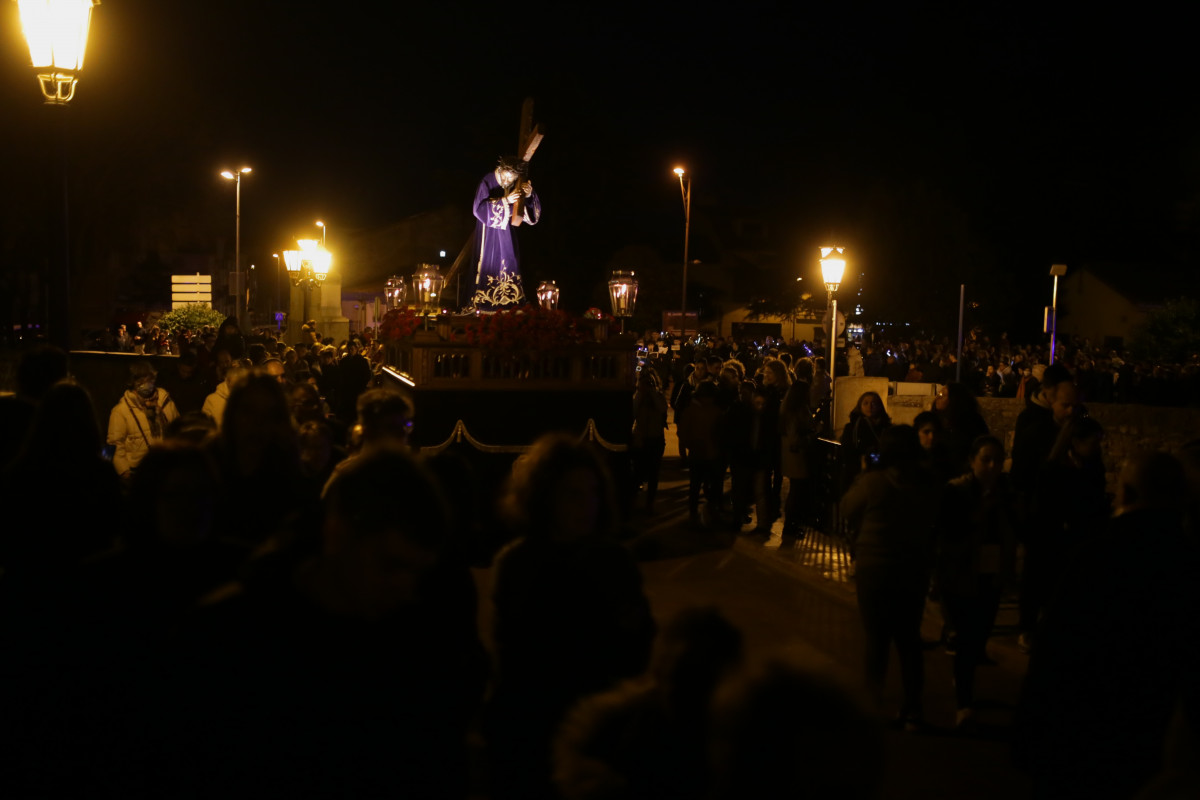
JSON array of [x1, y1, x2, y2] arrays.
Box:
[[1018, 453, 1200, 800]]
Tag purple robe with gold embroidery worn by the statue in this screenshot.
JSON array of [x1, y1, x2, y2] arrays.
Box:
[[472, 170, 541, 311]]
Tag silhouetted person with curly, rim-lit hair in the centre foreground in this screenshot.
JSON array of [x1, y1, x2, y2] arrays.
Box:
[[485, 434, 657, 800]]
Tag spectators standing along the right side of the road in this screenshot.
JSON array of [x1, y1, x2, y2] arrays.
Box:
[[634, 341, 1200, 798]]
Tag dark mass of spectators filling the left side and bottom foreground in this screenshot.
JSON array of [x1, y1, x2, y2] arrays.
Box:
[[0, 344, 882, 799]]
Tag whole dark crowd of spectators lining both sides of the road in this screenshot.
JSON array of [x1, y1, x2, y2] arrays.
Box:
[[0, 320, 1200, 799]]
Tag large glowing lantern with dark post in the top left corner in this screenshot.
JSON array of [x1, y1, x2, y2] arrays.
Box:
[[17, 0, 100, 350]]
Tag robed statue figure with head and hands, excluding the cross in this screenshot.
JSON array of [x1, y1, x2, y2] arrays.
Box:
[[472, 157, 541, 311]]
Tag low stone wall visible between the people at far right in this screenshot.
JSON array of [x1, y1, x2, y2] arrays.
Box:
[[979, 397, 1200, 491]]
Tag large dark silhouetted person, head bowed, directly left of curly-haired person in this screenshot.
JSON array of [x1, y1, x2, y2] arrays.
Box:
[[170, 450, 486, 798]]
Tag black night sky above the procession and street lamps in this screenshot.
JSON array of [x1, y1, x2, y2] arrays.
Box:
[[0, 0, 1200, 338]]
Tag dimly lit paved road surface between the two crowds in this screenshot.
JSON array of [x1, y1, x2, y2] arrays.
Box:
[[635, 438, 1028, 800]]
